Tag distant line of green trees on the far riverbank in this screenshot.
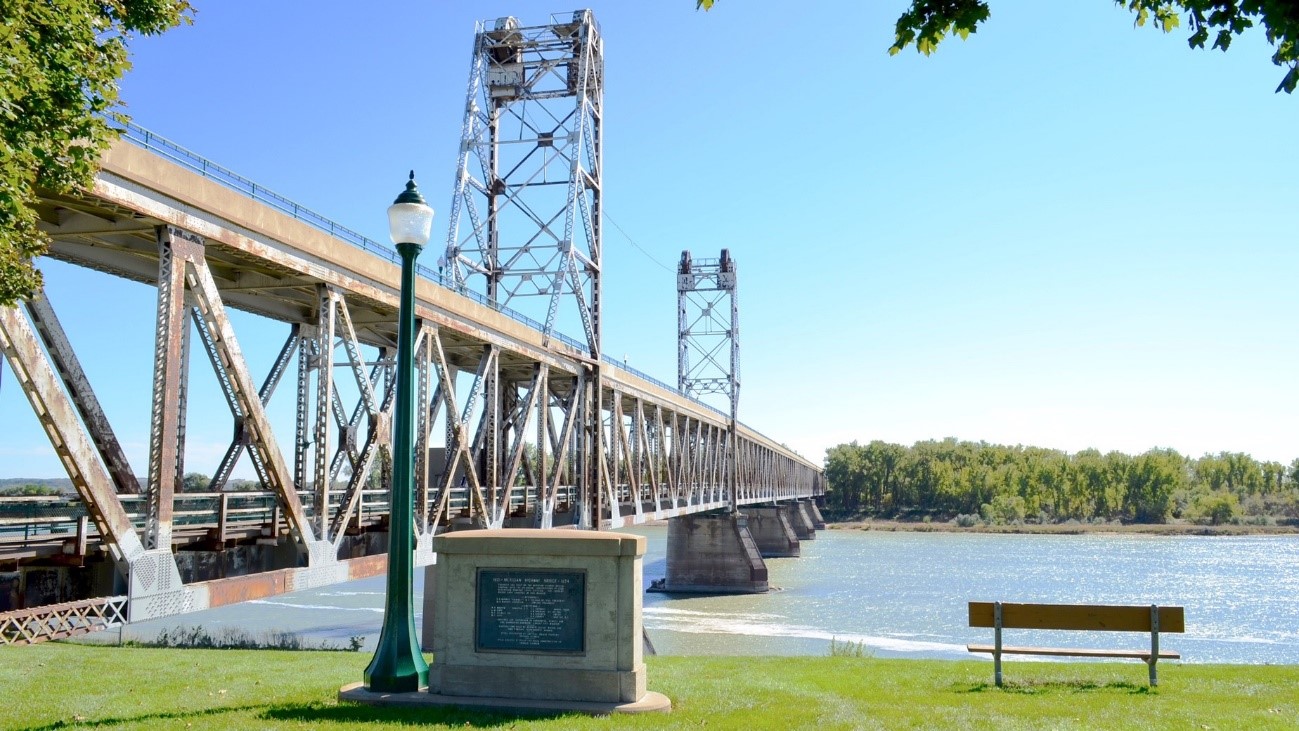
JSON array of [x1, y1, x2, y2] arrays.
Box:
[[825, 439, 1299, 525]]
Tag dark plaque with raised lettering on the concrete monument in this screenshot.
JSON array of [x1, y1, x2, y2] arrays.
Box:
[[474, 569, 586, 652]]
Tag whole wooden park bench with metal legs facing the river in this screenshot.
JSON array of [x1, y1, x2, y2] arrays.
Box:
[[965, 601, 1186, 686]]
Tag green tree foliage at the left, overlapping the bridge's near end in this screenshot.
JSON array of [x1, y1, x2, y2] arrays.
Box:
[[0, 0, 190, 306]]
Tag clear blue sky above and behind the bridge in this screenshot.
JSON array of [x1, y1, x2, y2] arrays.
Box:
[[0, 0, 1299, 477]]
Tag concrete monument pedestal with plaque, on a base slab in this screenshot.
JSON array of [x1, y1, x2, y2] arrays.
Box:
[[339, 528, 672, 714]]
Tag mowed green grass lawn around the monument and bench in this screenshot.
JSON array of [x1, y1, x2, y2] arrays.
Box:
[[0, 644, 1299, 731]]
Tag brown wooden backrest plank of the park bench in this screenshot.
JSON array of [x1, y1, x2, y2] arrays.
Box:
[[970, 601, 1186, 632]]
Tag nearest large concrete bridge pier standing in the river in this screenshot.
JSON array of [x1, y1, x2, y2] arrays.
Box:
[[662, 513, 768, 593]]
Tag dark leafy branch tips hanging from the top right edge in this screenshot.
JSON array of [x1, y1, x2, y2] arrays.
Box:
[[695, 0, 1299, 93]]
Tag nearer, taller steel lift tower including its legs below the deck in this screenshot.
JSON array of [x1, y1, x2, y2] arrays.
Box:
[[444, 10, 609, 527]]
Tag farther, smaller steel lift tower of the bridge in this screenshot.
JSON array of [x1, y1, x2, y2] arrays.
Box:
[[677, 249, 739, 509]]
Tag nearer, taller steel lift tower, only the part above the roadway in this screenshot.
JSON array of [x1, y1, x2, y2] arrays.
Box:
[[446, 10, 604, 360]]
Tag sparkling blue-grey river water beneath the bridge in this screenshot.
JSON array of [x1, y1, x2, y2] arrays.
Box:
[[103, 526, 1299, 665]]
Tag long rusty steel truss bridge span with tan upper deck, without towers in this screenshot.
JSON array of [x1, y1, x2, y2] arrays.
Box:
[[0, 126, 824, 641]]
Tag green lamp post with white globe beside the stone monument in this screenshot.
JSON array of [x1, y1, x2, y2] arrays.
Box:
[[365, 170, 433, 693]]
